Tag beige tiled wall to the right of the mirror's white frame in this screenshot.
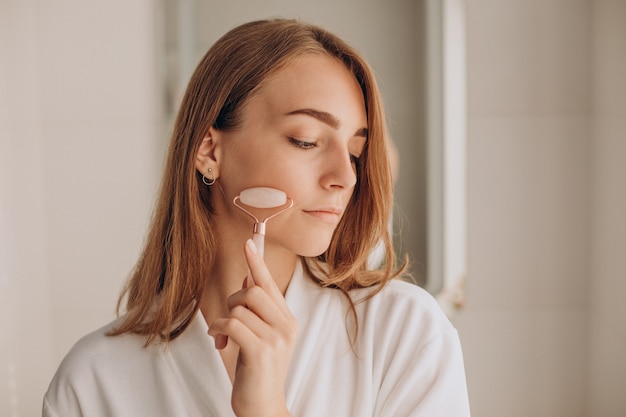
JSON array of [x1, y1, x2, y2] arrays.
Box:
[[456, 0, 626, 417]]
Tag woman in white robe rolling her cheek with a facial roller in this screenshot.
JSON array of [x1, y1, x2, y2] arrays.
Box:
[[43, 19, 469, 417]]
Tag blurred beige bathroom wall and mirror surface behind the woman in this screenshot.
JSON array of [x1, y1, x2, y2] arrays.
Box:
[[0, 0, 626, 417]]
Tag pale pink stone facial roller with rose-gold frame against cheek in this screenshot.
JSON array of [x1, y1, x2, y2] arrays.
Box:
[[233, 187, 293, 256]]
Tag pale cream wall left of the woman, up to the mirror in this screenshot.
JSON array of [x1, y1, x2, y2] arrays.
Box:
[[0, 0, 162, 417]]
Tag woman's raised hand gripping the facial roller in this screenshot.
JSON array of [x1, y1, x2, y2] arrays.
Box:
[[209, 240, 298, 417]]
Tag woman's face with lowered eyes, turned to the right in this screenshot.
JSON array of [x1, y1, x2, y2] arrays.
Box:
[[211, 55, 367, 256]]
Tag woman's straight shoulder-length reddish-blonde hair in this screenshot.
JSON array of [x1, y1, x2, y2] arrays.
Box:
[[110, 19, 403, 344]]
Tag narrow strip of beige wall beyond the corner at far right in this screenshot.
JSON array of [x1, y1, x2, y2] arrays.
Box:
[[588, 0, 626, 417]]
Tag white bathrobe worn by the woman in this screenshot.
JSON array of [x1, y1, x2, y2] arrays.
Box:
[[43, 267, 470, 417]]
